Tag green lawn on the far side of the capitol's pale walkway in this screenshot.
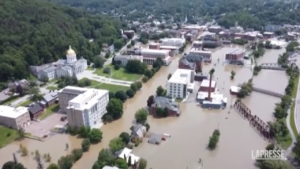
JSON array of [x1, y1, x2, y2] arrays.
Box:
[[95, 65, 142, 81]]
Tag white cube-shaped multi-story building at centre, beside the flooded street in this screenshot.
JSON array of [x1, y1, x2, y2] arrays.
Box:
[[167, 69, 195, 98]]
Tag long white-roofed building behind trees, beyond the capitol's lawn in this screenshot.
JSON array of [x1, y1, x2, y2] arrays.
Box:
[[137, 48, 172, 65]]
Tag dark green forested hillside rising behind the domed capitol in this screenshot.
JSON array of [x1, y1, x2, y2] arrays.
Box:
[[0, 0, 126, 81]]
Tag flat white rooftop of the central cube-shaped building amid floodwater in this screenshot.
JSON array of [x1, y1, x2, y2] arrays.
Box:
[[168, 69, 192, 84]]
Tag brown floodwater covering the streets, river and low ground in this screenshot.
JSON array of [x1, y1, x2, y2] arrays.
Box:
[[0, 47, 287, 169]]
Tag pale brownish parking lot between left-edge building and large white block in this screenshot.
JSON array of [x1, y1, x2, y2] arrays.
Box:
[[25, 113, 68, 138]]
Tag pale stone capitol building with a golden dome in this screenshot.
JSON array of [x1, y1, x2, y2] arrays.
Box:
[[30, 46, 87, 80]]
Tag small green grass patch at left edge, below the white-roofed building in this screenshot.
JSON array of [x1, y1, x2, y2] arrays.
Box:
[[0, 126, 19, 148]]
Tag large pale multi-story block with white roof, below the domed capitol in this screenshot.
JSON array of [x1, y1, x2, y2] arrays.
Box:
[[59, 86, 109, 128]]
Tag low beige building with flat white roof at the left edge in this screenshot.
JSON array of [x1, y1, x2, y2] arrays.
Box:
[[0, 105, 30, 130]]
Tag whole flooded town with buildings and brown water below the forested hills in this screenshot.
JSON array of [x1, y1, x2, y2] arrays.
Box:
[[0, 2, 300, 169]]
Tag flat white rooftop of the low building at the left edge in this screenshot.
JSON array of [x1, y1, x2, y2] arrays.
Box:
[[0, 105, 28, 118]]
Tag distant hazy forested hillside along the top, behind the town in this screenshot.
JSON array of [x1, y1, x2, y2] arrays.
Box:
[[49, 0, 300, 29]]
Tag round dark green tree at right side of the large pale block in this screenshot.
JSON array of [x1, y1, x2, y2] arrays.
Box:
[[106, 99, 123, 119]]
